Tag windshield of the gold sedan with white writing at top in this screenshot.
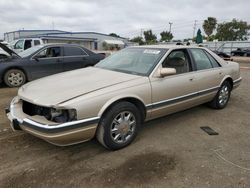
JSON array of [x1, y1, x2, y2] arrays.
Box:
[[96, 47, 167, 76]]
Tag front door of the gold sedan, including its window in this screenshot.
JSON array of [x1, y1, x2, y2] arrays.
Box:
[[147, 49, 199, 117]]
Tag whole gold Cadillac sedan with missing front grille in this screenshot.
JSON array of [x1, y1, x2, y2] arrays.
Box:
[[6, 45, 241, 150]]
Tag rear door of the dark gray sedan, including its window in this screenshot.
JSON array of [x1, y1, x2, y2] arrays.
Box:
[[63, 46, 91, 71]]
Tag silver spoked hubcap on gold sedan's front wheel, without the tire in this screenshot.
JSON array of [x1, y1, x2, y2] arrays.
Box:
[[111, 111, 136, 144]]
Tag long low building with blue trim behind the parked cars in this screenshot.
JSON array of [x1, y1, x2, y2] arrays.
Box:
[[4, 30, 134, 50]]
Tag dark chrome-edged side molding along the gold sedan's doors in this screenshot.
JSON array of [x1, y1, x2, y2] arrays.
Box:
[[146, 86, 220, 108]]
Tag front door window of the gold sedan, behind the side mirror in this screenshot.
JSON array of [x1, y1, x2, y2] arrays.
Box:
[[162, 50, 190, 74]]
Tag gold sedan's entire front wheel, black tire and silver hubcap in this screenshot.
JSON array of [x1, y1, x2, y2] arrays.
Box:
[[96, 102, 141, 150]]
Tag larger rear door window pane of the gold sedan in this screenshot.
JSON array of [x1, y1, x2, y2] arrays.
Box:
[[190, 49, 213, 70]]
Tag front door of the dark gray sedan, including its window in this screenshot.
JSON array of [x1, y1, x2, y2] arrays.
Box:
[[29, 46, 63, 79]]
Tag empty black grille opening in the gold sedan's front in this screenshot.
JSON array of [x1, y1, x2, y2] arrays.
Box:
[[23, 101, 51, 118]]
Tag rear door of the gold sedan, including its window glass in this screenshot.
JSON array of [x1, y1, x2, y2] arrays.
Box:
[[189, 48, 224, 100]]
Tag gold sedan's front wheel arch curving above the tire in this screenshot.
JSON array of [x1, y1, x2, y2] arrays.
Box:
[[98, 96, 147, 121]]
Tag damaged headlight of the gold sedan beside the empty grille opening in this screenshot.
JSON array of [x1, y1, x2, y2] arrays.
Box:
[[50, 108, 77, 123]]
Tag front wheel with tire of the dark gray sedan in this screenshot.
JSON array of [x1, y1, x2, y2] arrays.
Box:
[[4, 69, 26, 87]]
